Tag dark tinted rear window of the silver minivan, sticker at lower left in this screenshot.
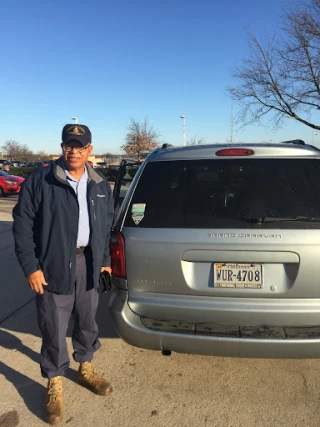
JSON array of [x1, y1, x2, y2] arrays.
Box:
[[125, 158, 320, 229]]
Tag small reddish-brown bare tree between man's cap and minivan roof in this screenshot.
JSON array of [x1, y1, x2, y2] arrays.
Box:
[[121, 118, 160, 160]]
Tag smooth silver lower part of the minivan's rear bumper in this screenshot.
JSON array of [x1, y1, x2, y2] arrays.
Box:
[[109, 287, 320, 359]]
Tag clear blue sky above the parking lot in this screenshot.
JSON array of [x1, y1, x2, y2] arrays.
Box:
[[0, 0, 320, 154]]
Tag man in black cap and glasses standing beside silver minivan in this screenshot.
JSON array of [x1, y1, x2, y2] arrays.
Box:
[[13, 124, 113, 424]]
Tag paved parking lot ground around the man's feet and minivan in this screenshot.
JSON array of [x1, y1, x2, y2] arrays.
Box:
[[0, 196, 320, 427]]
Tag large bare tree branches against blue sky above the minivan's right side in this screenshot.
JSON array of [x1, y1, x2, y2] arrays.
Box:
[[229, 0, 320, 130]]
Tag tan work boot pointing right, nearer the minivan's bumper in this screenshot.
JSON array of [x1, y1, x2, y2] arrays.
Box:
[[78, 362, 112, 396]]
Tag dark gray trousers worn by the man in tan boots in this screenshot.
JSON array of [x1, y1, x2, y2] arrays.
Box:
[[36, 253, 101, 378]]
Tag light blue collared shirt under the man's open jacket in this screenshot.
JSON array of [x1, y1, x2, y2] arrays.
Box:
[[64, 166, 90, 247]]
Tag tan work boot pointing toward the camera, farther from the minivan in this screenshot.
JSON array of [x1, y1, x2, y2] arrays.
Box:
[[46, 377, 63, 425]]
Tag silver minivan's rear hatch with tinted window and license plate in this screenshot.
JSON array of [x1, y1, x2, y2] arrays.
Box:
[[122, 156, 320, 305]]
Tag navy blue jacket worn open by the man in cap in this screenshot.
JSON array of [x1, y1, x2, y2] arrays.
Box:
[[13, 158, 113, 294]]
